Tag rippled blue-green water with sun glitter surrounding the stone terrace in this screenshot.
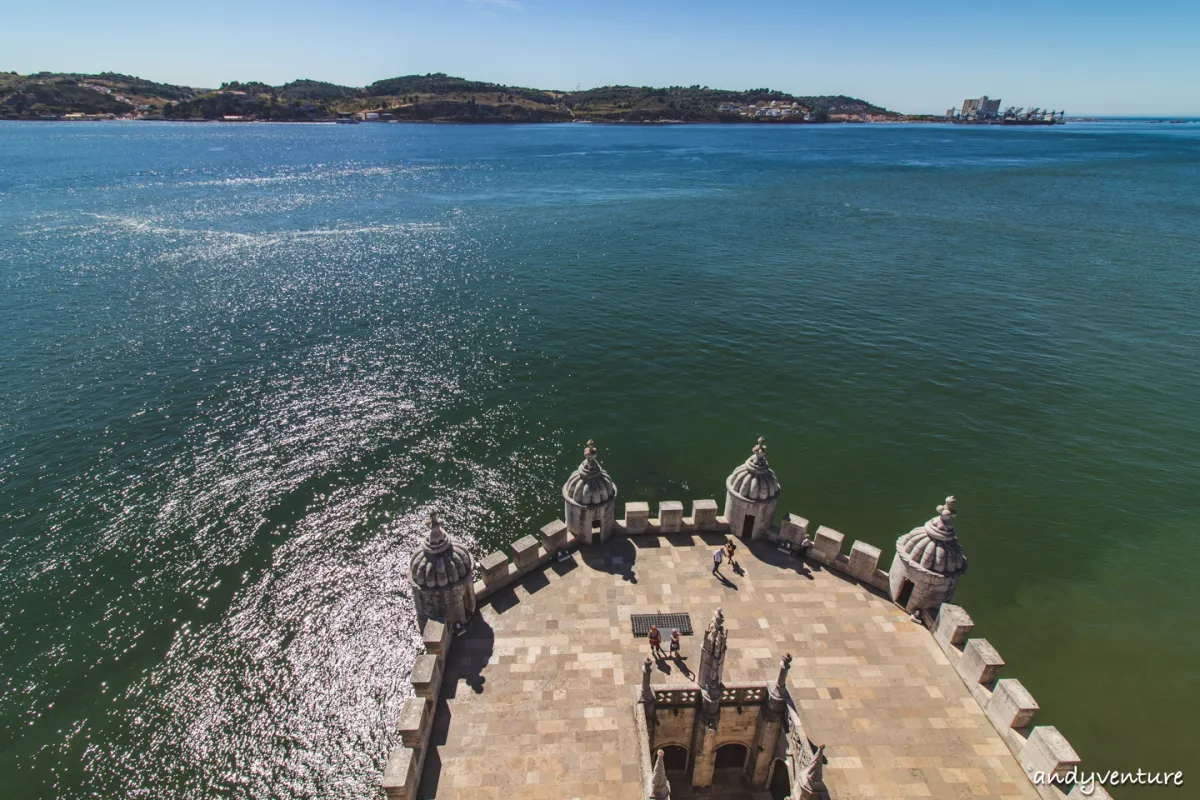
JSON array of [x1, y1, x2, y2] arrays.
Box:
[[0, 124, 1200, 799]]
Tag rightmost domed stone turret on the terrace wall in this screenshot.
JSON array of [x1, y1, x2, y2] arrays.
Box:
[[888, 495, 967, 613]]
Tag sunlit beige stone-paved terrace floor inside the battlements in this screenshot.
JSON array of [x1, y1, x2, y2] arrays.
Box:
[[420, 535, 1038, 800]]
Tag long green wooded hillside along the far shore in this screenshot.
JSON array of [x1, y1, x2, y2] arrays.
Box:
[[0, 72, 898, 122]]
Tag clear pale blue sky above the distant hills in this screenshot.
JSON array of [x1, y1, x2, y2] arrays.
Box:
[[0, 0, 1200, 115]]
